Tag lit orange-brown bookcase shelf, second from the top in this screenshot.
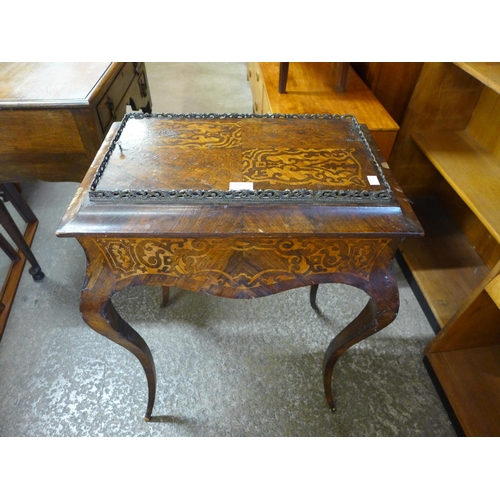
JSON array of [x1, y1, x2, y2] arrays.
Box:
[[411, 131, 500, 242]]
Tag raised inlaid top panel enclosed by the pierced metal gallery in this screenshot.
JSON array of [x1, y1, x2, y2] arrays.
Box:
[[90, 114, 392, 203]]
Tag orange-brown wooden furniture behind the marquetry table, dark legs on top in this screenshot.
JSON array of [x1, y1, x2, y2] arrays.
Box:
[[247, 62, 399, 158]]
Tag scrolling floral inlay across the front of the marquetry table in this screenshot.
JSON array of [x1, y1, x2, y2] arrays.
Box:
[[96, 238, 390, 289]]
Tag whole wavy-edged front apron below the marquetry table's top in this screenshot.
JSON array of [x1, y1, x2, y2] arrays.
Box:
[[79, 236, 400, 298]]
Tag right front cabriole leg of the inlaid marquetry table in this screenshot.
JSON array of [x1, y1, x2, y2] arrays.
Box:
[[323, 267, 399, 411]]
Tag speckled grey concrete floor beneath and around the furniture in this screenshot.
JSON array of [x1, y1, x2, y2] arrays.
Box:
[[0, 63, 455, 436]]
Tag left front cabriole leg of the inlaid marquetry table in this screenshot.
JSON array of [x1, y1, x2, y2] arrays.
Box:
[[80, 249, 156, 421]]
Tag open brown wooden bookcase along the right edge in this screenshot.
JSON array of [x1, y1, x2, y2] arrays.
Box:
[[389, 63, 500, 436]]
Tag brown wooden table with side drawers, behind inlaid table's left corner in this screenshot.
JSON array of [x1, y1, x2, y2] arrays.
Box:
[[0, 62, 152, 182]]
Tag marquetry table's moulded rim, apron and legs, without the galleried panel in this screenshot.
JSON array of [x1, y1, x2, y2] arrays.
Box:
[[57, 114, 422, 420]]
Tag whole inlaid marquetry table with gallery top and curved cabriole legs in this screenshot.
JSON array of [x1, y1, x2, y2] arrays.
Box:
[[57, 114, 422, 420]]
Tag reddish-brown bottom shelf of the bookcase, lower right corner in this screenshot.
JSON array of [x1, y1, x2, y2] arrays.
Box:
[[427, 345, 500, 436]]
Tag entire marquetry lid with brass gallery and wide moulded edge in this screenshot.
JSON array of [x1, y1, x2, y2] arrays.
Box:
[[58, 114, 421, 237]]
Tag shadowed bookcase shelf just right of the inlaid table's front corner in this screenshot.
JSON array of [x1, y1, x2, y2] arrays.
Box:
[[401, 197, 489, 327]]
